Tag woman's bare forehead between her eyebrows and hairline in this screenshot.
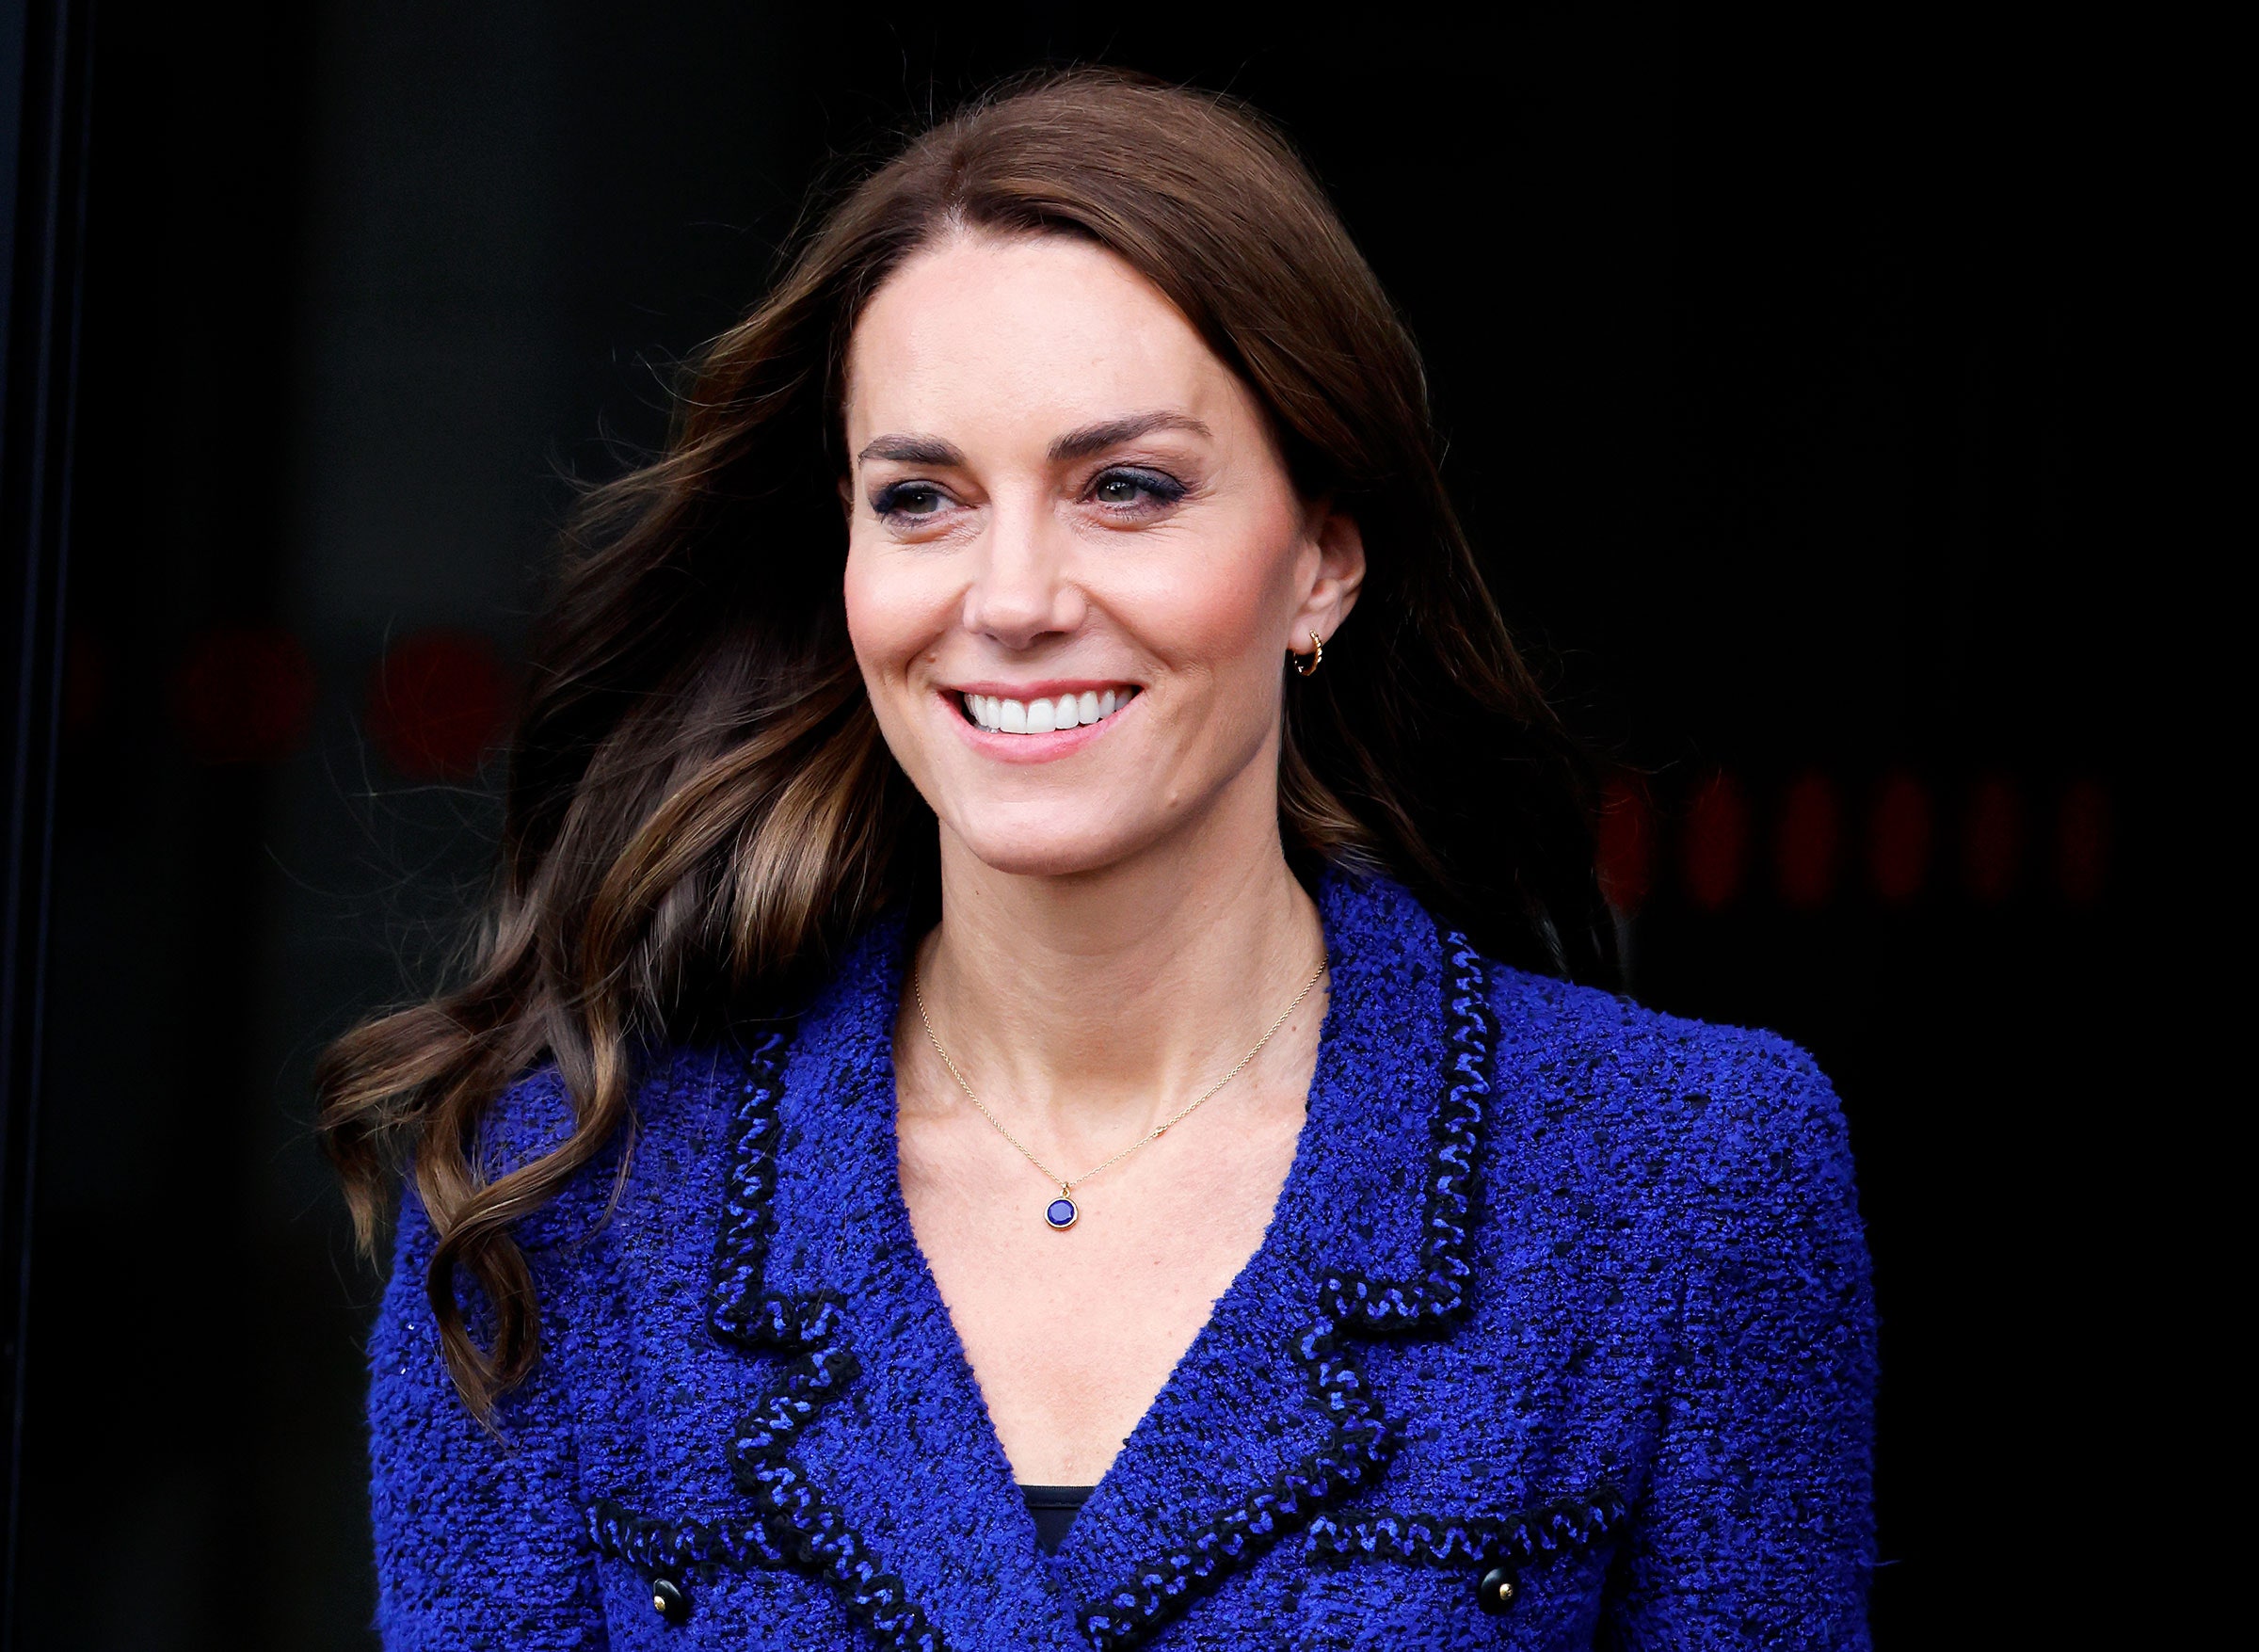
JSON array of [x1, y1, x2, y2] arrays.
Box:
[[847, 233, 1256, 450]]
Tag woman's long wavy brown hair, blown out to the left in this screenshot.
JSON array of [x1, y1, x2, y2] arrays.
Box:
[[318, 70, 1613, 1415]]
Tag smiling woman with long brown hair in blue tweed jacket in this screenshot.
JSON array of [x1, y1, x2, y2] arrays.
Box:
[[323, 74, 1873, 1647]]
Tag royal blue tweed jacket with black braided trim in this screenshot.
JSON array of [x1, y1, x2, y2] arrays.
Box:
[[368, 877, 1875, 1652]]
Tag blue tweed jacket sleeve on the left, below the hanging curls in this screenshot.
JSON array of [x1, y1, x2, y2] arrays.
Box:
[[368, 1189, 605, 1652]]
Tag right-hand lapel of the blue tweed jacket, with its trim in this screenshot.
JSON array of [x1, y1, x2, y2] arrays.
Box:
[[1034, 877, 1489, 1647]]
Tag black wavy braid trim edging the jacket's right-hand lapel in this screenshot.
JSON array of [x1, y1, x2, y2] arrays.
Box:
[[1080, 931, 1498, 1652]]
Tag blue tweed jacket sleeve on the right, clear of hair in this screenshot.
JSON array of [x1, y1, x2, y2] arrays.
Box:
[[1609, 1037, 1875, 1652]]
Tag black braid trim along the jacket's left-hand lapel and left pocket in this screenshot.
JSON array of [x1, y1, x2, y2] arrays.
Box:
[[587, 1033, 947, 1652]]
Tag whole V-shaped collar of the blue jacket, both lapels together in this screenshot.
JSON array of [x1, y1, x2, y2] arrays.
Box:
[[707, 877, 1493, 1647]]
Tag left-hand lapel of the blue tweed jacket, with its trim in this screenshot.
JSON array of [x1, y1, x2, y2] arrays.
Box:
[[712, 924, 1075, 1652]]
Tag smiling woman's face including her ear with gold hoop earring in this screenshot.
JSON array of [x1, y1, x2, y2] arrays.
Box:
[[842, 235, 1365, 874]]
